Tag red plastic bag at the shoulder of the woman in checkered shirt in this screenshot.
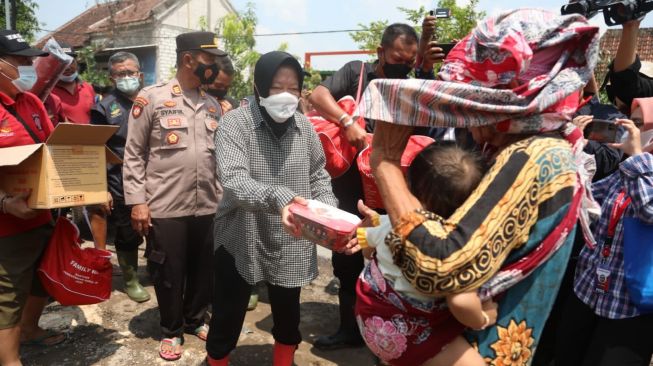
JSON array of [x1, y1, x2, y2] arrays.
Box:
[[306, 96, 365, 178]]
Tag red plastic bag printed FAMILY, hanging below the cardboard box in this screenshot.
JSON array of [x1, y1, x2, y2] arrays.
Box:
[[38, 217, 113, 305]]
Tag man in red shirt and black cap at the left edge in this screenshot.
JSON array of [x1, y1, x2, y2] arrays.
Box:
[[0, 30, 66, 366]]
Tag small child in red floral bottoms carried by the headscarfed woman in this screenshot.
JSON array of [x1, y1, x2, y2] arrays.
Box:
[[356, 143, 497, 366]]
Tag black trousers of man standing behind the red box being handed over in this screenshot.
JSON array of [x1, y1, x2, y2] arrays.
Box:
[[331, 159, 365, 335]]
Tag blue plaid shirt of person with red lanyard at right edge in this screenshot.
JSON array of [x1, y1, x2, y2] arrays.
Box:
[[574, 153, 653, 319]]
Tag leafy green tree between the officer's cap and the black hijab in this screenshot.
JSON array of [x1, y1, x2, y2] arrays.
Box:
[[216, 2, 260, 100]]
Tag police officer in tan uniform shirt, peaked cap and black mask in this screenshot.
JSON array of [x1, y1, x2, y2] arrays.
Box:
[[123, 32, 226, 360]]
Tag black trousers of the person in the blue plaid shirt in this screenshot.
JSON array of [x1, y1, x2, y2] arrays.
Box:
[[555, 295, 653, 366]]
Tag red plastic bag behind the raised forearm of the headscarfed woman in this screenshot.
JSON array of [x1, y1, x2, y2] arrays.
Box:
[[356, 135, 435, 208]]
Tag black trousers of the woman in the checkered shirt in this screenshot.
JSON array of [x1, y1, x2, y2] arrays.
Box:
[[206, 247, 302, 359]]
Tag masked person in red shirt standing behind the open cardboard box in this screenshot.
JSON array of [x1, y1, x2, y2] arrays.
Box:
[[52, 42, 95, 124]]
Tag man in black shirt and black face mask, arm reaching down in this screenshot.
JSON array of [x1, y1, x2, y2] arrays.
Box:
[[310, 16, 444, 349]]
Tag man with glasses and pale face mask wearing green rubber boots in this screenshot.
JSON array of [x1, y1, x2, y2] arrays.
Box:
[[88, 52, 150, 302]]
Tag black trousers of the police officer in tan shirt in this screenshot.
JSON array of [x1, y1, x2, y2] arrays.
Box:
[[145, 215, 213, 338]]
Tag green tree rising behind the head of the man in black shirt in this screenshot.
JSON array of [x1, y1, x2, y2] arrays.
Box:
[[349, 0, 485, 57]]
